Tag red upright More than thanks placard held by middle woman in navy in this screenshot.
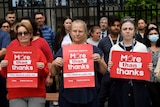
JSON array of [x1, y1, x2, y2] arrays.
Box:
[[63, 44, 95, 88]]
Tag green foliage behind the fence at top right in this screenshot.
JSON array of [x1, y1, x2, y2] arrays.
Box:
[[117, 0, 160, 21]]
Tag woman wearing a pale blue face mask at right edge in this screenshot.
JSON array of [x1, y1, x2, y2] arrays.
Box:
[[144, 24, 160, 107]]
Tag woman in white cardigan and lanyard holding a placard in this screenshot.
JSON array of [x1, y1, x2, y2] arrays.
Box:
[[108, 18, 152, 107]]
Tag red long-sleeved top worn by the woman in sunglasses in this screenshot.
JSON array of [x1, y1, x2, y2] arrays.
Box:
[[1, 46, 49, 100]]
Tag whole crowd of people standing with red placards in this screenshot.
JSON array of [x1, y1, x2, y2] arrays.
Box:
[[0, 11, 160, 107]]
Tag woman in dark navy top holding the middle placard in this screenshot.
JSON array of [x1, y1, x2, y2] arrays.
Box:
[[52, 20, 107, 107]]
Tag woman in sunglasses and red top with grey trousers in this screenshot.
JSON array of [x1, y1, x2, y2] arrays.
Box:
[[1, 22, 49, 107]]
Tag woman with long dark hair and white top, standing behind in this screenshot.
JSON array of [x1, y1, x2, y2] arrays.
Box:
[[54, 16, 72, 54]]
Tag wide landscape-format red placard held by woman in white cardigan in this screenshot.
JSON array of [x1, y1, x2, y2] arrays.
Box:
[[110, 51, 151, 80]]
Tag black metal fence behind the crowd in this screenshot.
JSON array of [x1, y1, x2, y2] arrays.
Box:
[[0, 0, 160, 31]]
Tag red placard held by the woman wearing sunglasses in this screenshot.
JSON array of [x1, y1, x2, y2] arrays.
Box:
[[7, 46, 38, 88]]
